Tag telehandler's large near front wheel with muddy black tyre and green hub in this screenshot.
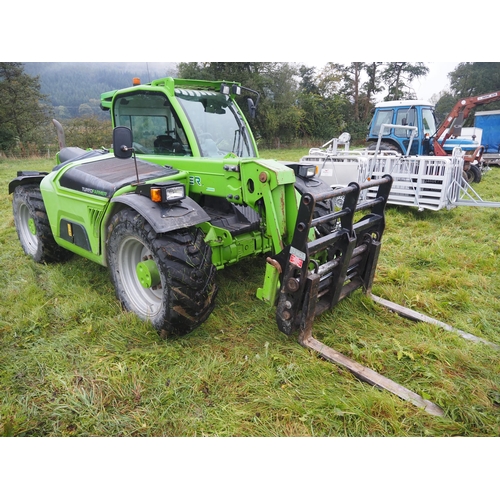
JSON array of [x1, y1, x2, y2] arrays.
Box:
[[106, 209, 217, 337]]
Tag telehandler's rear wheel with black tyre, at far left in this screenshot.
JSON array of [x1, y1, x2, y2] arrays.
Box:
[[12, 184, 72, 263]]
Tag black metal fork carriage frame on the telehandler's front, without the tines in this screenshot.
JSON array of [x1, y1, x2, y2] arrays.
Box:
[[274, 175, 392, 335]]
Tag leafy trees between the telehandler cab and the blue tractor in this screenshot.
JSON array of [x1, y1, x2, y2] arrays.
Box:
[[177, 62, 429, 147]]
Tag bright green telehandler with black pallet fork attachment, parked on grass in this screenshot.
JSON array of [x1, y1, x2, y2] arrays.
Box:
[[9, 78, 452, 415]]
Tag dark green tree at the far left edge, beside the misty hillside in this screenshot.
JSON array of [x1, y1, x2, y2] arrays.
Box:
[[0, 62, 50, 152]]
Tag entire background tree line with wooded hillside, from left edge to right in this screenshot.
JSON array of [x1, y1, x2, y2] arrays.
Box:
[[0, 62, 500, 155]]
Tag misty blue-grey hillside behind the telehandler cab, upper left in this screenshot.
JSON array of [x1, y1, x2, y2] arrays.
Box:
[[24, 62, 176, 118]]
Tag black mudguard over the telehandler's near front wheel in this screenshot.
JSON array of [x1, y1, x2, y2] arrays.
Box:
[[112, 193, 210, 234]]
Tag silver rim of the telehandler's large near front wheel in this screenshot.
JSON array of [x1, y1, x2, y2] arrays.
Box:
[[118, 237, 163, 317]]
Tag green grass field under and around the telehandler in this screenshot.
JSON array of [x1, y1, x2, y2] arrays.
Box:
[[0, 154, 500, 436]]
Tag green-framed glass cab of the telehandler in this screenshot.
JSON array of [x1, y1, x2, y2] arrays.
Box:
[[101, 78, 257, 158]]
